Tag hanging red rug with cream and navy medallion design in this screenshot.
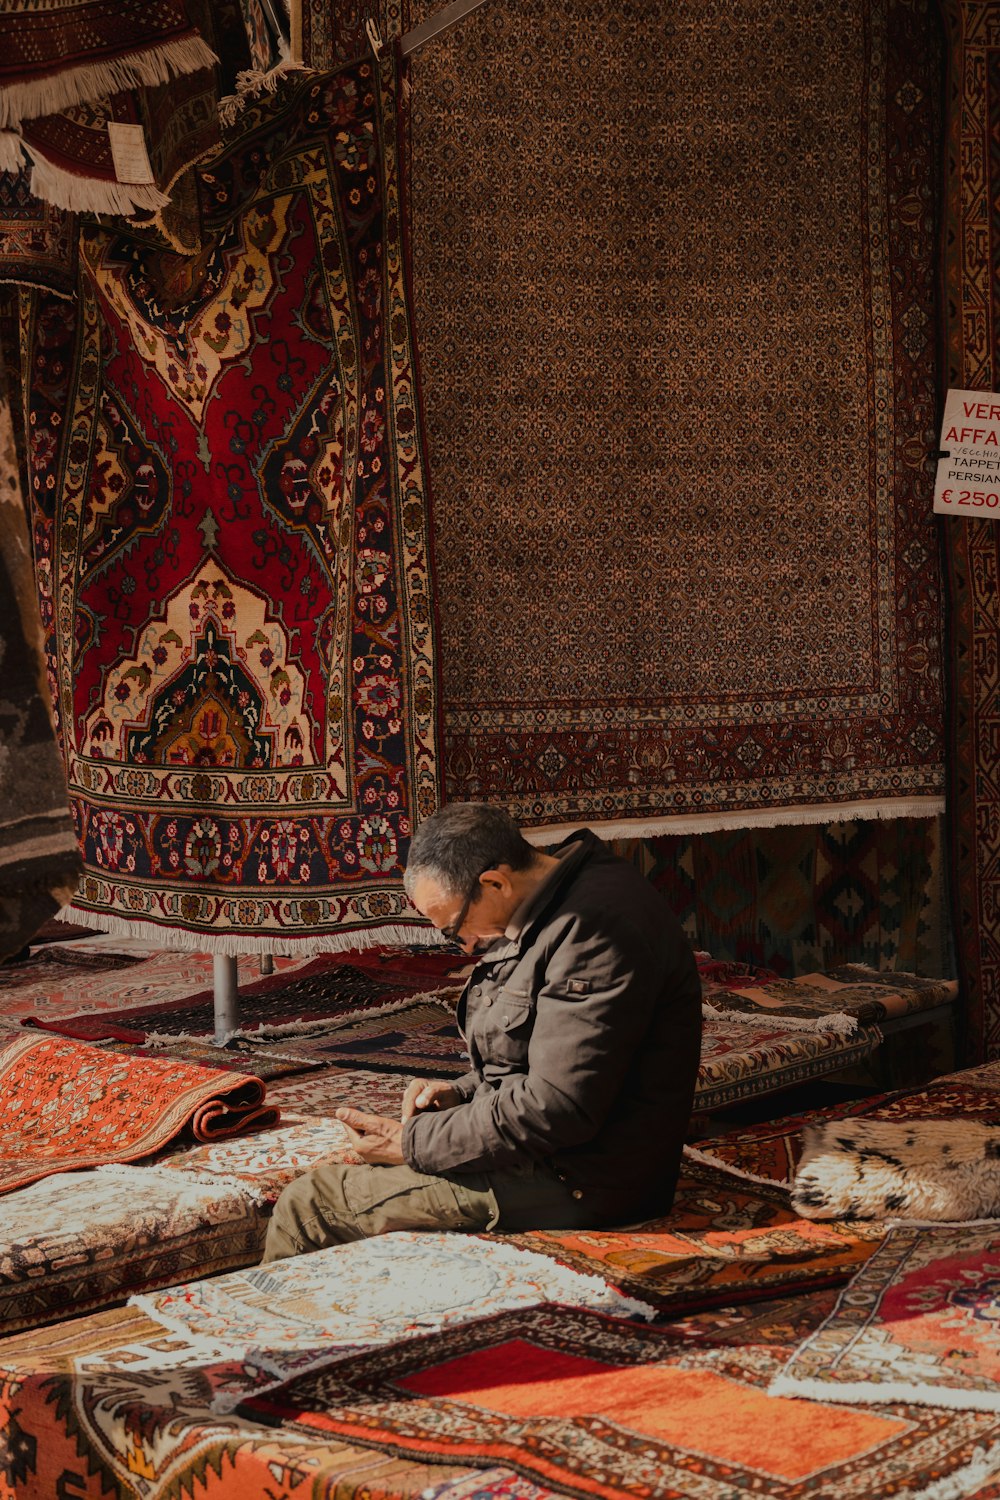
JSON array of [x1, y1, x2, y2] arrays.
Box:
[[25, 59, 439, 953]]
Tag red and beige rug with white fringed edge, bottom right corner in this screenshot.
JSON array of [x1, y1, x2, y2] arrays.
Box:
[[771, 1223, 1000, 1416]]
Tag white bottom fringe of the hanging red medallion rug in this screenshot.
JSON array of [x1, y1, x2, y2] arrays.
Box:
[[55, 902, 444, 959]]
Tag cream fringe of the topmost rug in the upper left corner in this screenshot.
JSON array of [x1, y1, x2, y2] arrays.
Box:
[[0, 36, 219, 129]]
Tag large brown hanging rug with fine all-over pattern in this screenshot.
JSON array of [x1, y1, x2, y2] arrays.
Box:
[[411, 0, 947, 833]]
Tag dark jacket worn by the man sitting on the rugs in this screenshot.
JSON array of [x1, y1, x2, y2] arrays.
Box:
[[403, 830, 702, 1227]]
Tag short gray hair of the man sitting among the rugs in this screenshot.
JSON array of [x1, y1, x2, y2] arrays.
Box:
[[403, 803, 535, 897]]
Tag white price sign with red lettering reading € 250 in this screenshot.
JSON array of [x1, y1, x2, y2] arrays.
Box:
[[934, 390, 1000, 521]]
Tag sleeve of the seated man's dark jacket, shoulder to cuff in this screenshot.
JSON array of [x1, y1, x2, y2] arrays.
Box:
[[403, 914, 663, 1173]]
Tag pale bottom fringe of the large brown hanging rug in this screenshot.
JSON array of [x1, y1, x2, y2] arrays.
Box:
[[522, 797, 945, 845]]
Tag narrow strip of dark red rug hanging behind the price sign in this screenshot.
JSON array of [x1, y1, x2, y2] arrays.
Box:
[[942, 0, 1000, 1062]]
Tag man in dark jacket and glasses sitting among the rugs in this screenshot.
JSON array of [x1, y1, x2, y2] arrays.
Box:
[[264, 803, 702, 1260]]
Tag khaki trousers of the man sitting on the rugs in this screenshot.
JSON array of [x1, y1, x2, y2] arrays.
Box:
[[264, 1163, 588, 1262]]
